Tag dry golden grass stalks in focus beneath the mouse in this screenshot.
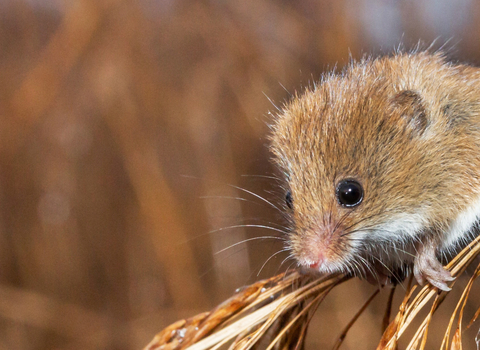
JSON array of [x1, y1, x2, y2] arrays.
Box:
[[145, 236, 480, 350]]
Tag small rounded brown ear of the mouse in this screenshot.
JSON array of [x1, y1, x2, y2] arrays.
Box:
[[392, 90, 428, 135]]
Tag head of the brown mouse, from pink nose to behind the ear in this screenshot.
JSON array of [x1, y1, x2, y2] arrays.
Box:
[[271, 53, 480, 272]]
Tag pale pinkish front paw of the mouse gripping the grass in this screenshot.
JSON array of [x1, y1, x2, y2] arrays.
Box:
[[413, 249, 455, 292]]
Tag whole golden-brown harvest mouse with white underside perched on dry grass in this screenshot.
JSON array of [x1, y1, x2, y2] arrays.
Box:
[[271, 52, 480, 291]]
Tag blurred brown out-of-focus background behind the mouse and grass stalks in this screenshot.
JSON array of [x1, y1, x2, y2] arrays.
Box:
[[0, 0, 480, 349]]
